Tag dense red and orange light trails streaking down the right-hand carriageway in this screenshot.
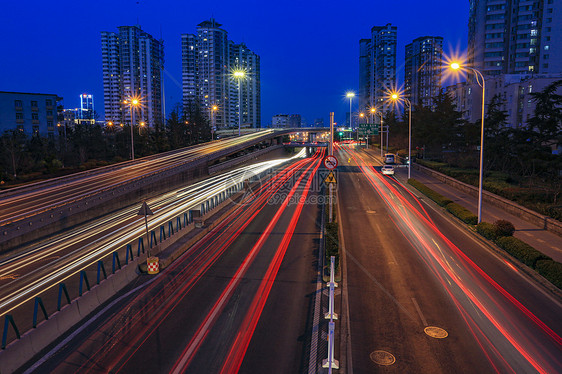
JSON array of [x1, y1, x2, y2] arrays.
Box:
[[342, 147, 562, 373]]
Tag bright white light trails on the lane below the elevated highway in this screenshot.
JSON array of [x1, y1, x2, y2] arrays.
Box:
[[0, 152, 303, 322]]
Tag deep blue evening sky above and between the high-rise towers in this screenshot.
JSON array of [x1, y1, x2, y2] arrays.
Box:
[[0, 0, 469, 125]]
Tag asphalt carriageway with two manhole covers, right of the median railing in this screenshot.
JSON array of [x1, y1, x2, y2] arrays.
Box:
[[332, 145, 562, 373]]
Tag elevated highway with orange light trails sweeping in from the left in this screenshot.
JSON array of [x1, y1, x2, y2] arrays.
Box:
[[0, 128, 326, 254]]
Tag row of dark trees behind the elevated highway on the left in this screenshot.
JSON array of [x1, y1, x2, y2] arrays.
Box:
[[0, 105, 211, 189]]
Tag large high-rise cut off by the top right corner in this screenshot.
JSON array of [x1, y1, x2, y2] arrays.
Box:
[[468, 0, 562, 76]]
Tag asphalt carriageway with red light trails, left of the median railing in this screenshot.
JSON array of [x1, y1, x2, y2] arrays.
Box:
[[27, 150, 320, 373]]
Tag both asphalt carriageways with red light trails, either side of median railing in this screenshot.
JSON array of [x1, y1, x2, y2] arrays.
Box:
[[4, 141, 562, 373]]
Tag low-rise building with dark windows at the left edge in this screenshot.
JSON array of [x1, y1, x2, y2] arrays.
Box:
[[0, 91, 62, 138]]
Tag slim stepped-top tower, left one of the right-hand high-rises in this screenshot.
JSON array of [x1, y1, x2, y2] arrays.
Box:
[[359, 23, 398, 111]]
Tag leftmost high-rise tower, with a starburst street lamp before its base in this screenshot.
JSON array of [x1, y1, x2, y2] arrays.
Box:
[[101, 26, 164, 126]]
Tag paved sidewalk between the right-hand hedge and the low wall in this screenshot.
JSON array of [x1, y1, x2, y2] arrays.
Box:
[[358, 148, 562, 262]]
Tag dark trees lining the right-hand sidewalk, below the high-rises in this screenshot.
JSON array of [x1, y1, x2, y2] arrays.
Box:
[[373, 80, 562, 221]]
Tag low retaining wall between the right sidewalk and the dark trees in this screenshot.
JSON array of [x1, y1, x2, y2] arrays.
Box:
[[412, 164, 562, 236]]
